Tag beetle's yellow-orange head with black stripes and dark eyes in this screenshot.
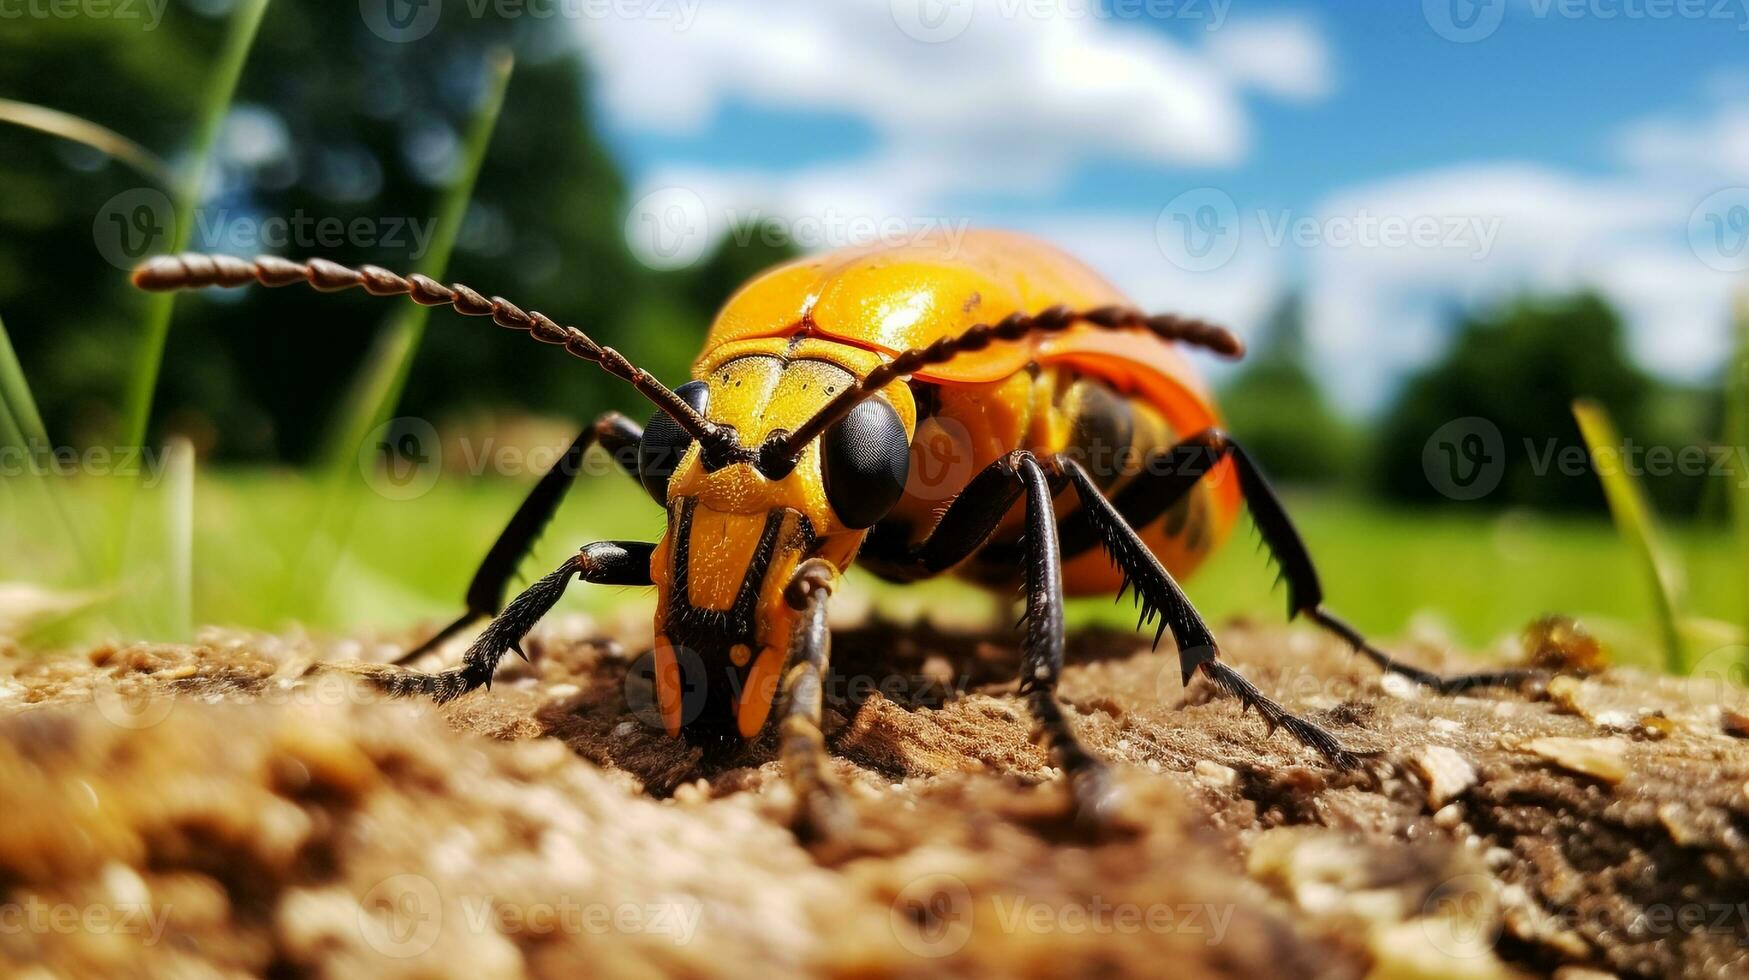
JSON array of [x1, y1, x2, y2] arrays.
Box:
[[638, 345, 916, 747]]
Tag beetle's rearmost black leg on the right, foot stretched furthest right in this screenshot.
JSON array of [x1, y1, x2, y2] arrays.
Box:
[[1063, 429, 1539, 693]]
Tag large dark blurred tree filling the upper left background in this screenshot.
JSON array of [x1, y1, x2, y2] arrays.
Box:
[[0, 0, 790, 462]]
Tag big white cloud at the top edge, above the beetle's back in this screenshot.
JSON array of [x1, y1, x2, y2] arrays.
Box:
[[581, 0, 1331, 189]]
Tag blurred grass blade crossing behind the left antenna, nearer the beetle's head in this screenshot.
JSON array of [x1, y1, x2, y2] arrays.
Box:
[[282, 49, 516, 616]]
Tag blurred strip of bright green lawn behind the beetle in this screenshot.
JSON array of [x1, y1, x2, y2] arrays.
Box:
[[7, 471, 1739, 667]]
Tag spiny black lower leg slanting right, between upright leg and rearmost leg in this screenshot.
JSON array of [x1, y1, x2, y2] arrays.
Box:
[[1056, 457, 1361, 768]]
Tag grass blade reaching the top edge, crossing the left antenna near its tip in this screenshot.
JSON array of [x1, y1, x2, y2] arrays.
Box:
[[121, 0, 268, 458]]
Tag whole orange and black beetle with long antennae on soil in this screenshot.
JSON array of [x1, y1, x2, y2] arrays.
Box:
[[133, 231, 1532, 837]]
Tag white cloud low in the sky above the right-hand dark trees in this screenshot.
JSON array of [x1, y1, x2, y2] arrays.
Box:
[[1308, 165, 1737, 408]]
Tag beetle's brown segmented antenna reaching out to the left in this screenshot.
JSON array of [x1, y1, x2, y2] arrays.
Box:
[[133, 252, 745, 459]]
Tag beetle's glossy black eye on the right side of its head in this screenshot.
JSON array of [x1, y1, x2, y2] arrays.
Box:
[[820, 399, 911, 529]]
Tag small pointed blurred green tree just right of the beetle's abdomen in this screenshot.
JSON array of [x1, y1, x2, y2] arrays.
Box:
[[1221, 292, 1357, 483]]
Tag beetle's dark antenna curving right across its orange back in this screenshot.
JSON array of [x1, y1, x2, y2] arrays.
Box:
[[759, 306, 1245, 478]]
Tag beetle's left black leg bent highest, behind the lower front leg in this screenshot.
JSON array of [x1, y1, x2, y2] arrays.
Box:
[[395, 411, 644, 665]]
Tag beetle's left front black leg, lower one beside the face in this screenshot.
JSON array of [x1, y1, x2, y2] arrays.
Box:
[[355, 541, 656, 704]]
